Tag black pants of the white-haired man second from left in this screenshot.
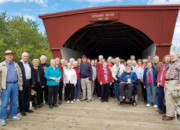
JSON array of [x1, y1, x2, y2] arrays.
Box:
[[19, 80, 31, 112]]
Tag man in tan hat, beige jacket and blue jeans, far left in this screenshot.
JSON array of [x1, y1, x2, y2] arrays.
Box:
[[0, 50, 23, 126]]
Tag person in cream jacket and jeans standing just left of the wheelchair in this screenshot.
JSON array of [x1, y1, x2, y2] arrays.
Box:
[[111, 57, 125, 102]]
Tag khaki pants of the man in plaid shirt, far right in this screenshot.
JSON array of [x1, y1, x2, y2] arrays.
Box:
[[164, 80, 178, 117]]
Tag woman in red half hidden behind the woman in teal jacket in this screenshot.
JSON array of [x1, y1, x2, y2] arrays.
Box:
[[55, 57, 64, 105]]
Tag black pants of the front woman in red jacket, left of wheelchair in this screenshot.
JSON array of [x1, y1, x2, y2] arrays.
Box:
[[101, 84, 109, 101]]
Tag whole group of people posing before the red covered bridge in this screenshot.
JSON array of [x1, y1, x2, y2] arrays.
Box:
[[0, 50, 180, 126]]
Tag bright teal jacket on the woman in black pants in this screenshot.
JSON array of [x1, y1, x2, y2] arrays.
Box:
[[45, 66, 62, 86]]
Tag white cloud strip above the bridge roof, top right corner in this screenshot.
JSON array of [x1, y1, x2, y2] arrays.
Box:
[[148, 0, 180, 5]]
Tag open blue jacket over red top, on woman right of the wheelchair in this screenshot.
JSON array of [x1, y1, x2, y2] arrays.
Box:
[[143, 67, 158, 87]]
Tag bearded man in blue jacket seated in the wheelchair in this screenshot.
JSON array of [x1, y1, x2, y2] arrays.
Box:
[[119, 66, 138, 102]]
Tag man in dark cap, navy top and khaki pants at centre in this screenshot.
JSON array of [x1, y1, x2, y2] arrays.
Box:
[[80, 55, 92, 102]]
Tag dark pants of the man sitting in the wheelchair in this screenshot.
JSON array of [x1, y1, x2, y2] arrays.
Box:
[[119, 83, 134, 99]]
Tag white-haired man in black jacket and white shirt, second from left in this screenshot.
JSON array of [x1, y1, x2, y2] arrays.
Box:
[[18, 52, 35, 116]]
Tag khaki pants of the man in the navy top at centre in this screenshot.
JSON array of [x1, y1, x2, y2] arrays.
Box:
[[81, 77, 92, 100]]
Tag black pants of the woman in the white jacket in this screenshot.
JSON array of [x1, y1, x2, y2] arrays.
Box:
[[66, 83, 74, 101]]
